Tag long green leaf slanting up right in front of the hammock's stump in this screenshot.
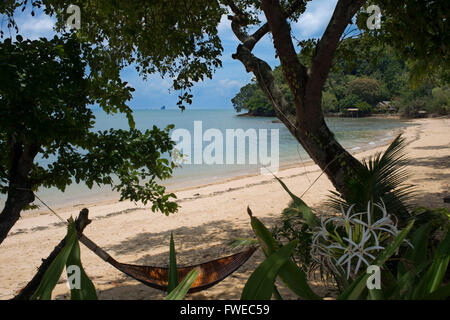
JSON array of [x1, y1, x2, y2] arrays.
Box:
[[31, 223, 78, 300]]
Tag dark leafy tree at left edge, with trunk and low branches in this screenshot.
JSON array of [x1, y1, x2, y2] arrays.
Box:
[[0, 35, 177, 243]]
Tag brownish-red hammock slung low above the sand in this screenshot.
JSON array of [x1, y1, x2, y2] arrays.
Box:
[[80, 234, 256, 293]]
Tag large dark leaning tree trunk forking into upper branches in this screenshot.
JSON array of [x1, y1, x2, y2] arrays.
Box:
[[229, 0, 365, 196]]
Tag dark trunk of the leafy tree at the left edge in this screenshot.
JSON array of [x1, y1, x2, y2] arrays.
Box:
[[0, 139, 40, 244]]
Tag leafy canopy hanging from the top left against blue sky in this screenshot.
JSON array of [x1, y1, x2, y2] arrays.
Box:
[[0, 0, 225, 109]]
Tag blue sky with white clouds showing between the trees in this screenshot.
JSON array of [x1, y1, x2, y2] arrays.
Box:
[[0, 0, 337, 109]]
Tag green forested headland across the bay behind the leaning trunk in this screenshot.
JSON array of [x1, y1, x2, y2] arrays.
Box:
[[231, 38, 450, 117]]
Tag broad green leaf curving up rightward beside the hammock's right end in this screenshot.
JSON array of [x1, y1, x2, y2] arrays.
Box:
[[241, 240, 298, 300]]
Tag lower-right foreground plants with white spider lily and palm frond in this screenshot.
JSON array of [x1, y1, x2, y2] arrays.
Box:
[[240, 136, 450, 299]]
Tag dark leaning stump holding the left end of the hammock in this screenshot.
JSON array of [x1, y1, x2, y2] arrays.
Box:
[[13, 208, 91, 300]]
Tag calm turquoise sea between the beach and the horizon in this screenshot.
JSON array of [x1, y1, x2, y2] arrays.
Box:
[[0, 109, 414, 207]]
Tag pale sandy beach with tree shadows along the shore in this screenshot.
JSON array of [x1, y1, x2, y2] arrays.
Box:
[[0, 118, 450, 299]]
